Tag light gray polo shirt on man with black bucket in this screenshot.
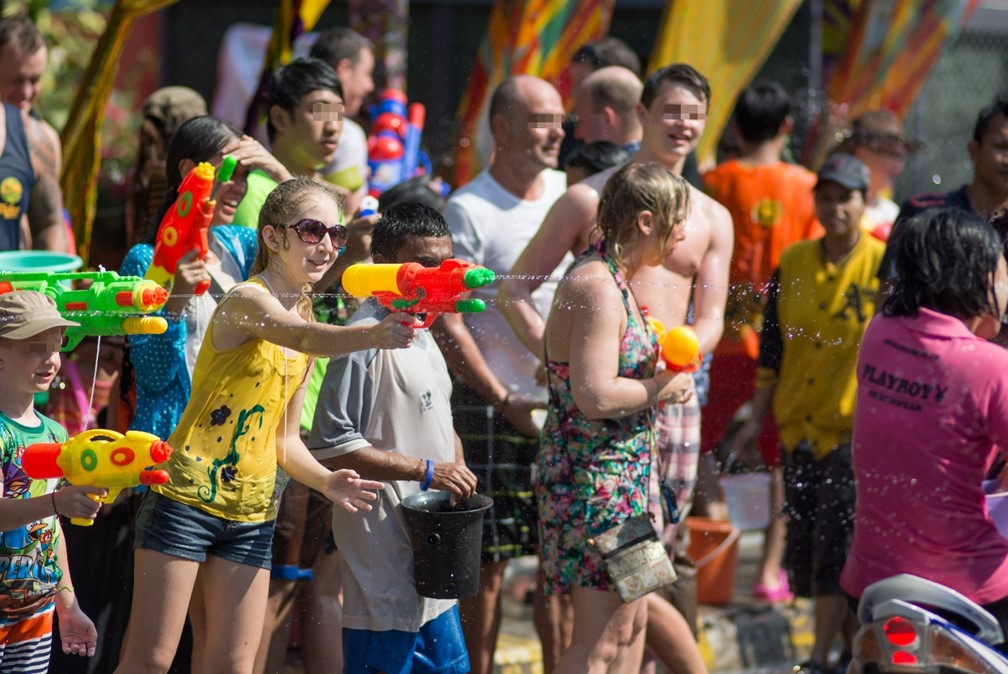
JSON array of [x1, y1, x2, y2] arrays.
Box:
[[308, 299, 455, 632]]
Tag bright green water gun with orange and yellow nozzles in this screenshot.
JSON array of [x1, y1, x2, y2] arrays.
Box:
[[0, 271, 168, 351]]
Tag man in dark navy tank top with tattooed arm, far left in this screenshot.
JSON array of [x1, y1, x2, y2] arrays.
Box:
[[0, 16, 70, 253]]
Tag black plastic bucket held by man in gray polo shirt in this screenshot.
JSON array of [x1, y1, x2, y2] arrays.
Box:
[[402, 492, 494, 599]]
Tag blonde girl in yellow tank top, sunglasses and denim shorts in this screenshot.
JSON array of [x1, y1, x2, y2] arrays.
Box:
[[116, 177, 413, 674]]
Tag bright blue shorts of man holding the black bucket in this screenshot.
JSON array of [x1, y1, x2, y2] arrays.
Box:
[[343, 606, 469, 674]]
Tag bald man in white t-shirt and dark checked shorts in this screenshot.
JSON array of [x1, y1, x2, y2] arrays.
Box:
[[434, 75, 572, 673]]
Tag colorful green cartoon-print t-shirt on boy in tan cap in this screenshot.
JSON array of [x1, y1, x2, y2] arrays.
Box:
[[0, 412, 67, 624]]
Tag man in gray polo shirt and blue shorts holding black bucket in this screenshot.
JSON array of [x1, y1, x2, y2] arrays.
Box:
[[308, 203, 476, 674]]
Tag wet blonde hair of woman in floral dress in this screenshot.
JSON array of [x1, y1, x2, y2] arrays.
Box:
[[597, 162, 689, 261]]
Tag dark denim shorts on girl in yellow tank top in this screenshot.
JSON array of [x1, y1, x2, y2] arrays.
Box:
[[133, 490, 274, 569]]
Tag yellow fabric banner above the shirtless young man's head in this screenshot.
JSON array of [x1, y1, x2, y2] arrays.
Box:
[[648, 0, 801, 163]]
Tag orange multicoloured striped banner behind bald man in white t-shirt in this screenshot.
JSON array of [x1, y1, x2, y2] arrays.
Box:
[[455, 0, 615, 185]]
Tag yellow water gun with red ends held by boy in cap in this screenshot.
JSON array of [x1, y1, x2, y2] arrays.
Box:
[[21, 428, 171, 527]]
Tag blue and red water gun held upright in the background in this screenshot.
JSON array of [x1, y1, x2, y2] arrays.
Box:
[[368, 89, 430, 196]]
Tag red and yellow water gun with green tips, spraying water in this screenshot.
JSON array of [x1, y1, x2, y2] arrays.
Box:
[[342, 258, 494, 327]]
